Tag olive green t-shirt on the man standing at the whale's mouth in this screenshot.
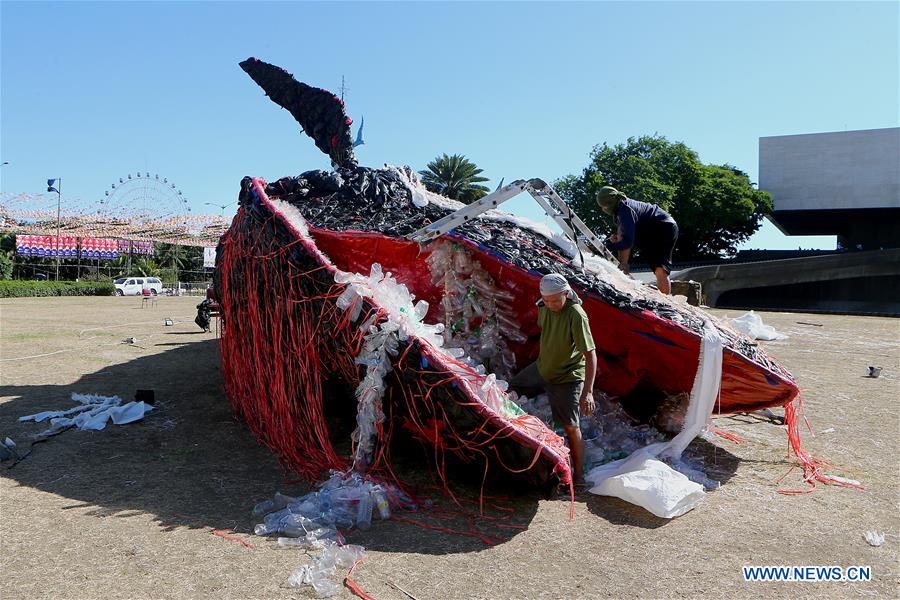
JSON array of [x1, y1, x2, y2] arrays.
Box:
[[538, 300, 595, 383]]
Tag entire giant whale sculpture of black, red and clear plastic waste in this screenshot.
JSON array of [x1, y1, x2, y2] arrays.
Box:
[[215, 58, 844, 490]]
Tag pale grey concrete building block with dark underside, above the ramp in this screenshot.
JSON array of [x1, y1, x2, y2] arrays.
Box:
[[759, 127, 900, 250]]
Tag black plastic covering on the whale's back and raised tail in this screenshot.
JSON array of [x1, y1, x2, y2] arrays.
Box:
[[232, 58, 784, 372]]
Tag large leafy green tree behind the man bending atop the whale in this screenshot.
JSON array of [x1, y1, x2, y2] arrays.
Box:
[[555, 135, 772, 260]]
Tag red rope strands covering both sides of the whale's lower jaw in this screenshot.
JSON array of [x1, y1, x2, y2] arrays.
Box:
[[217, 193, 570, 506]]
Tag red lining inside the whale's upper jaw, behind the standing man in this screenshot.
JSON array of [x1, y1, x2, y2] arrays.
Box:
[[310, 227, 799, 413]]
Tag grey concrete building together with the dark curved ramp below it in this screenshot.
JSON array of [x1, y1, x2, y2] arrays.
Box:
[[675, 128, 900, 316]]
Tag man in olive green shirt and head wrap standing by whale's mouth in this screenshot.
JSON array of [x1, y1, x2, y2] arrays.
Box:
[[509, 273, 597, 485]]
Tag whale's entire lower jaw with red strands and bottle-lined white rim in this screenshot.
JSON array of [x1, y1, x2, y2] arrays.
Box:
[[217, 180, 569, 494]]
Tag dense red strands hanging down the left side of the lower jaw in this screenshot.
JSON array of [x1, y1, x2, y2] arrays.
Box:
[[218, 208, 361, 480]]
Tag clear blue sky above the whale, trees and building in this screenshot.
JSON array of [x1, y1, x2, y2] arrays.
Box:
[[0, 1, 900, 248]]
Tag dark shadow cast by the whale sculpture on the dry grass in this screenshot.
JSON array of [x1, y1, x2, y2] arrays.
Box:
[[0, 339, 738, 554]]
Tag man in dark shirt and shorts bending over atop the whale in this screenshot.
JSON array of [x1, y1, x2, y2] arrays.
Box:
[[597, 185, 678, 294]]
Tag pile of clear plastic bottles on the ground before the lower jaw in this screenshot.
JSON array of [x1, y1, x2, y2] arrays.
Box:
[[251, 471, 418, 598]]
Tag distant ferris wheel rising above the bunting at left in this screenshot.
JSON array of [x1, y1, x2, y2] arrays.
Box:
[[98, 171, 191, 225]]
